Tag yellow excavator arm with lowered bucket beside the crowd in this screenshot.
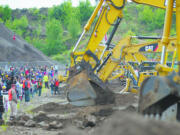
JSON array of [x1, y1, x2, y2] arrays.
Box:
[[67, 0, 126, 106]]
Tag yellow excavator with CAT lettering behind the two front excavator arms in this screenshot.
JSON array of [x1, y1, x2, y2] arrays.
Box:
[[98, 37, 176, 93]]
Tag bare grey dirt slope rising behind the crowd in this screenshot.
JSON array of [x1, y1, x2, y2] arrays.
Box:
[[0, 23, 51, 63]]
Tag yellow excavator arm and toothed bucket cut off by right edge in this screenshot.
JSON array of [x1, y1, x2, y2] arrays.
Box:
[[136, 0, 180, 120]]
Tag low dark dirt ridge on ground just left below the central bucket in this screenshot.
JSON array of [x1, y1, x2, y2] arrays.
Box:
[[32, 102, 77, 114]]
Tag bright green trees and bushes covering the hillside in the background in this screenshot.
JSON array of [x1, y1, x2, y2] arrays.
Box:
[[0, 0, 175, 60]]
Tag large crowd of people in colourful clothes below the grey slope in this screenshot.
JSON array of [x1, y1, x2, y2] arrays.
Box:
[[0, 66, 60, 123]]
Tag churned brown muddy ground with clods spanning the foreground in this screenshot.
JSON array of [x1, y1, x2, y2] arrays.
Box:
[[1, 79, 180, 135]]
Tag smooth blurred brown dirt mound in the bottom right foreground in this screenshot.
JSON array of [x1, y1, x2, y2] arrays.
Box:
[[65, 112, 180, 135]]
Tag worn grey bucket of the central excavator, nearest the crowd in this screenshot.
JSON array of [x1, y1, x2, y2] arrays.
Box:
[[67, 70, 114, 106]]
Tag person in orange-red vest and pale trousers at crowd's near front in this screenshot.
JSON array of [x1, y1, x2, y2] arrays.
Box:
[[8, 84, 17, 120]]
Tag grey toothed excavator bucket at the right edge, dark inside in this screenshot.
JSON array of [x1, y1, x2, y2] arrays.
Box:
[[138, 72, 180, 117]]
